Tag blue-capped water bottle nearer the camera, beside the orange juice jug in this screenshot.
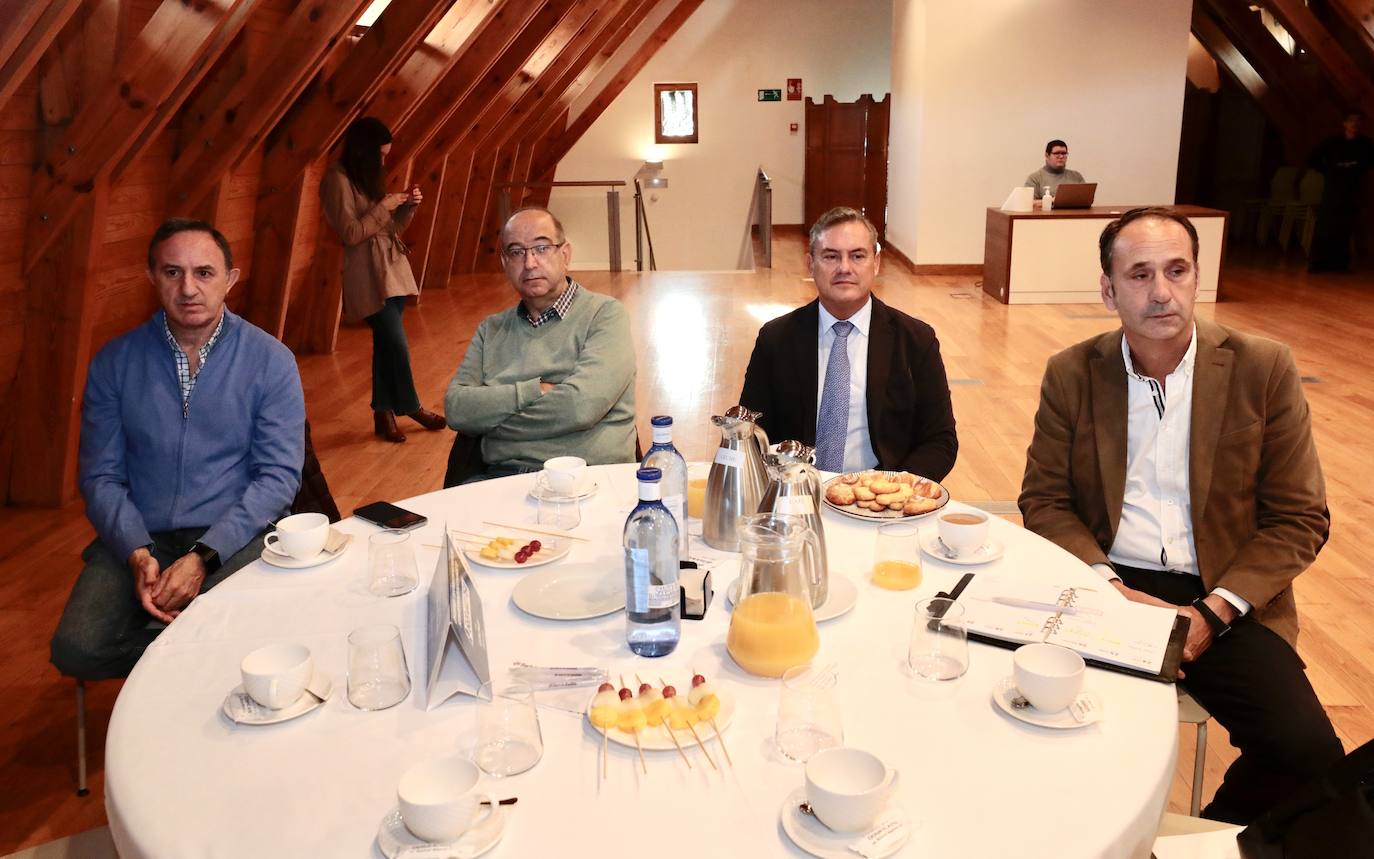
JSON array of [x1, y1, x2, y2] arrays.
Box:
[[625, 469, 682, 656]]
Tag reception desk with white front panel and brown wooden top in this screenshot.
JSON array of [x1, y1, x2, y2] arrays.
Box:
[[982, 206, 1227, 304]]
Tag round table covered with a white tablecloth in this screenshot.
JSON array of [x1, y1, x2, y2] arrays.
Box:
[[106, 465, 1178, 859]]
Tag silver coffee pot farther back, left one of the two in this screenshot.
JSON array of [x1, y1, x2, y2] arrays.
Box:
[[701, 405, 768, 551]]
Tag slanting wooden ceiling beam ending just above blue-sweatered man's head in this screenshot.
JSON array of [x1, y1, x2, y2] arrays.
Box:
[[172, 0, 370, 208]]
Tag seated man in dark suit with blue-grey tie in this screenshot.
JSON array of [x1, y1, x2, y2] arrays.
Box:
[[739, 208, 959, 480]]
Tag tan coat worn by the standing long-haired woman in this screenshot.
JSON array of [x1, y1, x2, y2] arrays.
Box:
[[320, 162, 420, 322]]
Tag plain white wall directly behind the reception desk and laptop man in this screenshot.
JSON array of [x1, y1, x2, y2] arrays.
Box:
[[888, 0, 1191, 264]]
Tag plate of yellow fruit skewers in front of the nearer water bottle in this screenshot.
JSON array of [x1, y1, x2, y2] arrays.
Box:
[[587, 673, 735, 755]]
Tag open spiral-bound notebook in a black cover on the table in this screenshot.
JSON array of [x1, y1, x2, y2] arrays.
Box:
[[949, 573, 1189, 683]]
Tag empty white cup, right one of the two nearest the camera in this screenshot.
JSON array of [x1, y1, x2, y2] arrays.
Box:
[[807, 746, 897, 832]]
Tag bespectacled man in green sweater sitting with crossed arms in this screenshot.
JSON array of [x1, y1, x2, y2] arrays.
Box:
[[444, 208, 635, 477]]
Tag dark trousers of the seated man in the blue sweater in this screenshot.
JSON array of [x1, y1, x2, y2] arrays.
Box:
[[51, 528, 264, 680]]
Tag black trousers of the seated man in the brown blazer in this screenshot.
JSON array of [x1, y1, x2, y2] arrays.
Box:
[[1116, 564, 1345, 825]]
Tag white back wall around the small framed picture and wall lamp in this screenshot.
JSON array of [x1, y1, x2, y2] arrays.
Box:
[[550, 0, 890, 271]]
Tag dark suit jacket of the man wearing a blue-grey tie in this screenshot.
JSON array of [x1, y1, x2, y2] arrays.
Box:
[[739, 295, 959, 480]]
